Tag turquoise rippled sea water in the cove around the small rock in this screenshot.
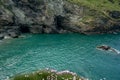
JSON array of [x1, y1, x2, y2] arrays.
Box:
[[0, 34, 120, 80]]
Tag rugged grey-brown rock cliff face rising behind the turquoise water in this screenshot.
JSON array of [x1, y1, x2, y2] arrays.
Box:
[[0, 0, 120, 37]]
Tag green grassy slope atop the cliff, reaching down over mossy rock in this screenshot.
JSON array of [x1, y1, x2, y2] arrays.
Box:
[[67, 0, 120, 26]]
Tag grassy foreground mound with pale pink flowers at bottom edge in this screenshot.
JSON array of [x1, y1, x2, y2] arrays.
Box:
[[11, 70, 84, 80]]
